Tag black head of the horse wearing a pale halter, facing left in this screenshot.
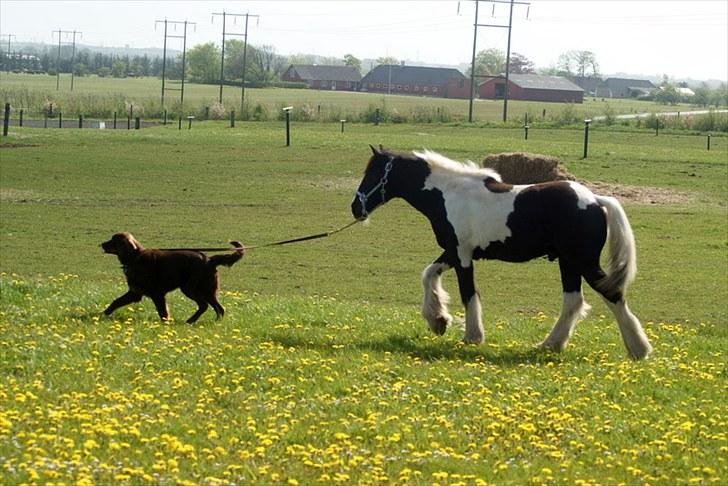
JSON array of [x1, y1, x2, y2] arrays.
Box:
[[351, 145, 394, 220]]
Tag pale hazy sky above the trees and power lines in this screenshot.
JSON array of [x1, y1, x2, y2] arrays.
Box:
[[0, 0, 728, 81]]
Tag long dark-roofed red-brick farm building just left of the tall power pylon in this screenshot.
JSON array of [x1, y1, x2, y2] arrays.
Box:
[[361, 64, 470, 99]]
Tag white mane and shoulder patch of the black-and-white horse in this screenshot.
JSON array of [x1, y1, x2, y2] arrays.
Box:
[[414, 151, 528, 267]]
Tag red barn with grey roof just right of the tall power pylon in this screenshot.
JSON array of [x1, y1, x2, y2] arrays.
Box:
[[478, 74, 584, 103]]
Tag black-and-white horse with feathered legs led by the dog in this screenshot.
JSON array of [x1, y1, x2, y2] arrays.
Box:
[[351, 145, 652, 360]]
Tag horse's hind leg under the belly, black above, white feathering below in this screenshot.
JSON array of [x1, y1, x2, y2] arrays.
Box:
[[539, 259, 591, 351]]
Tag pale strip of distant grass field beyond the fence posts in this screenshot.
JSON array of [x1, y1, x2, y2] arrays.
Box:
[[0, 72, 695, 123]]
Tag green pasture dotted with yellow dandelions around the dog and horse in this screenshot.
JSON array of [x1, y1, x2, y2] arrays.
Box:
[[0, 122, 728, 485]]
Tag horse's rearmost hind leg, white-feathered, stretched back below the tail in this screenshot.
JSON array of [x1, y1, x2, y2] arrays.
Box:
[[584, 265, 652, 359]]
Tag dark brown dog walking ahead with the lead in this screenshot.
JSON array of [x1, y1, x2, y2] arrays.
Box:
[[101, 233, 245, 323]]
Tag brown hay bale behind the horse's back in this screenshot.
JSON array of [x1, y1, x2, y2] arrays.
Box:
[[483, 152, 575, 184]]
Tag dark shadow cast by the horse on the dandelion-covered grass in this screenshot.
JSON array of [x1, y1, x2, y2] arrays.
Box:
[[270, 334, 562, 367]]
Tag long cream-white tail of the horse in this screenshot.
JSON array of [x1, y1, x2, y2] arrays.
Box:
[[596, 196, 637, 295]]
